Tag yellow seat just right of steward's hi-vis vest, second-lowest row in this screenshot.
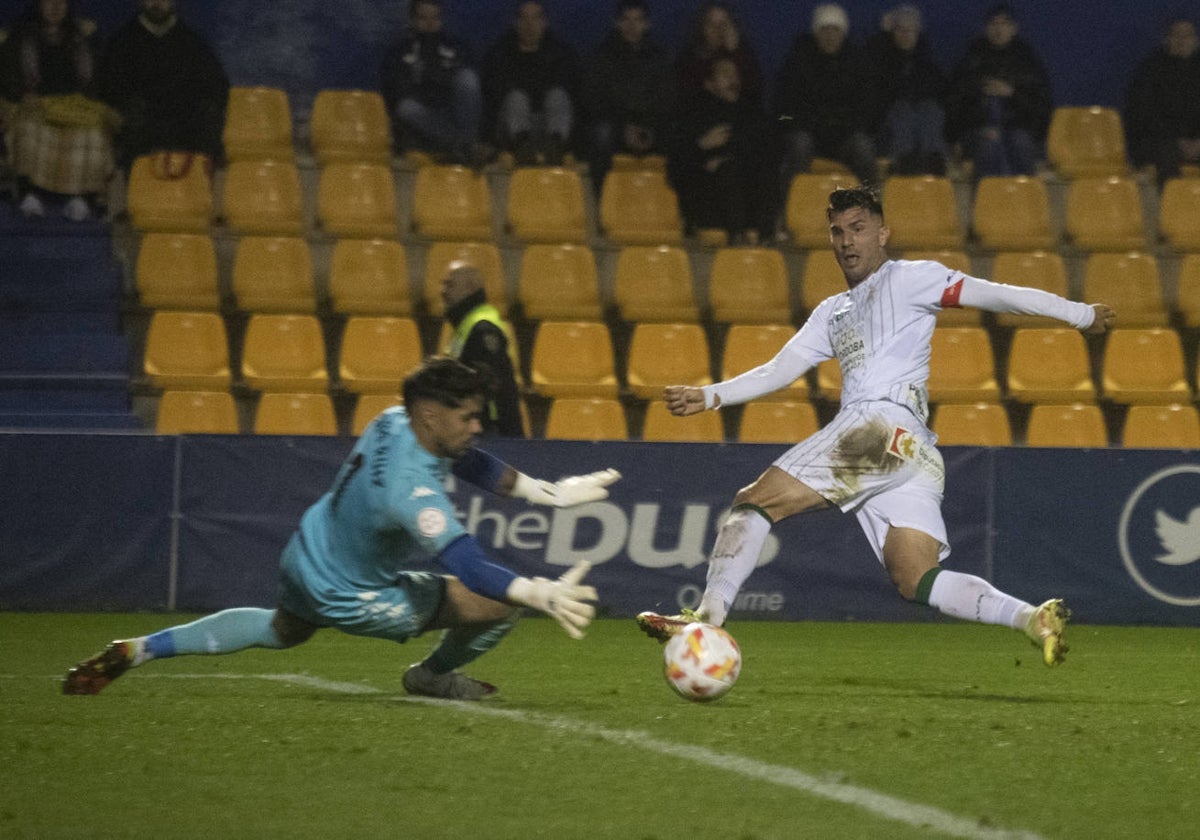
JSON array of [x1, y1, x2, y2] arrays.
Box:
[[530, 320, 617, 398]]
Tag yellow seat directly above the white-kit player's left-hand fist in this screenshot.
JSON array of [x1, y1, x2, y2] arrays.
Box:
[[625, 324, 713, 400]]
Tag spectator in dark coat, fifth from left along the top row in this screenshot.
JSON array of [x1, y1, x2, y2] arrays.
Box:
[[582, 0, 676, 192]]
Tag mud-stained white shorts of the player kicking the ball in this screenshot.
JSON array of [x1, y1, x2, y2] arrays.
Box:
[[774, 401, 950, 562]]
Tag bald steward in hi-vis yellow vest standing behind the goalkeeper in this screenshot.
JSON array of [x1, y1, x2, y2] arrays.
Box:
[[442, 260, 524, 438]]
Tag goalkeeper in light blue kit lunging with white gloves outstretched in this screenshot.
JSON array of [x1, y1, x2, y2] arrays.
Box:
[[62, 358, 620, 700]]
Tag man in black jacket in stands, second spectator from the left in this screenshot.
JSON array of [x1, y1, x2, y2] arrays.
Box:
[[100, 0, 229, 170]]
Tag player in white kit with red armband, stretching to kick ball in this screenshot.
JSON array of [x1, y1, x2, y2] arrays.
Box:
[[637, 187, 1115, 665]]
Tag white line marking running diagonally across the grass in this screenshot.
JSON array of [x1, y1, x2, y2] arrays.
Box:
[[139, 673, 1042, 840]]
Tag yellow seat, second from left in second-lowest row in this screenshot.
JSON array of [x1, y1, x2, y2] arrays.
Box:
[[241, 314, 329, 394]]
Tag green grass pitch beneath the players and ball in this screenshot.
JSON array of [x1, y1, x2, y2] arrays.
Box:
[[0, 613, 1200, 840]]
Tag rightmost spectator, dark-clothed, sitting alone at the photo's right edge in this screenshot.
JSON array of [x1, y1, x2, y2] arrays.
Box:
[[1124, 17, 1200, 186]]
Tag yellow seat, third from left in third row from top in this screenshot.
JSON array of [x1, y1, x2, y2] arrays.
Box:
[[329, 239, 413, 316]]
